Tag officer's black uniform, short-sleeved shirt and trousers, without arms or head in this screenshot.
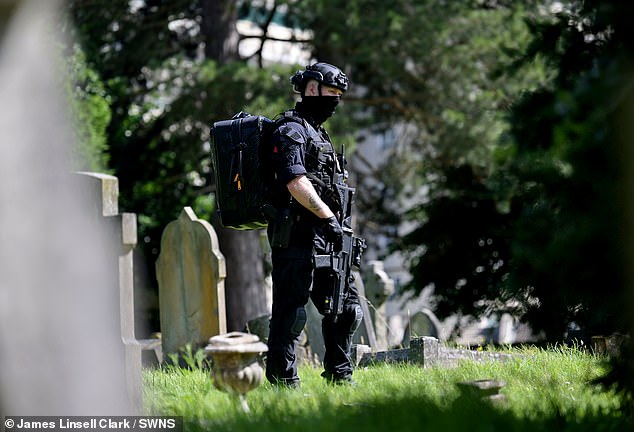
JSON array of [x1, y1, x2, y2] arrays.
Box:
[[266, 102, 362, 386]]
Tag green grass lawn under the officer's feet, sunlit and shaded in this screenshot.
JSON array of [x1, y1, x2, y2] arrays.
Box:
[[144, 348, 634, 432]]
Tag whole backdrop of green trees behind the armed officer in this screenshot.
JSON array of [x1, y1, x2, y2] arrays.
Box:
[[61, 0, 634, 352]]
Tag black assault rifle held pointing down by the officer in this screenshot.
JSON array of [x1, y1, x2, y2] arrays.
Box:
[[313, 149, 366, 321]]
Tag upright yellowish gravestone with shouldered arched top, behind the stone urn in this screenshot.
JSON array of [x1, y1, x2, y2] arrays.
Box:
[[156, 207, 227, 355]]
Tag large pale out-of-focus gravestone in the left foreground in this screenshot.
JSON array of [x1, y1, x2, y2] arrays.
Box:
[[0, 0, 128, 416]]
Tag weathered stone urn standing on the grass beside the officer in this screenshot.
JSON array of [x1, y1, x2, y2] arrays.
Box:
[[205, 332, 268, 412]]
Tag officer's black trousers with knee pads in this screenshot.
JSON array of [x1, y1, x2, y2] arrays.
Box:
[[266, 219, 362, 385]]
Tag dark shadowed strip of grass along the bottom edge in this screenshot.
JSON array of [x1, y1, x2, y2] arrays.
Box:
[[178, 395, 634, 432]]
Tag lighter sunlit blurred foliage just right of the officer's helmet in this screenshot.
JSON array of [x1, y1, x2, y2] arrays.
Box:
[[301, 0, 546, 243]]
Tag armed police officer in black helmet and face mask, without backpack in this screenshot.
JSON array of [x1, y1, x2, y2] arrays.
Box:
[[266, 62, 362, 387]]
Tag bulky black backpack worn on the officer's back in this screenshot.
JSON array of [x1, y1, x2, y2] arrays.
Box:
[[211, 112, 275, 230]]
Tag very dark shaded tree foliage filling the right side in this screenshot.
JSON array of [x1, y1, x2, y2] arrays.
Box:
[[396, 2, 632, 340]]
